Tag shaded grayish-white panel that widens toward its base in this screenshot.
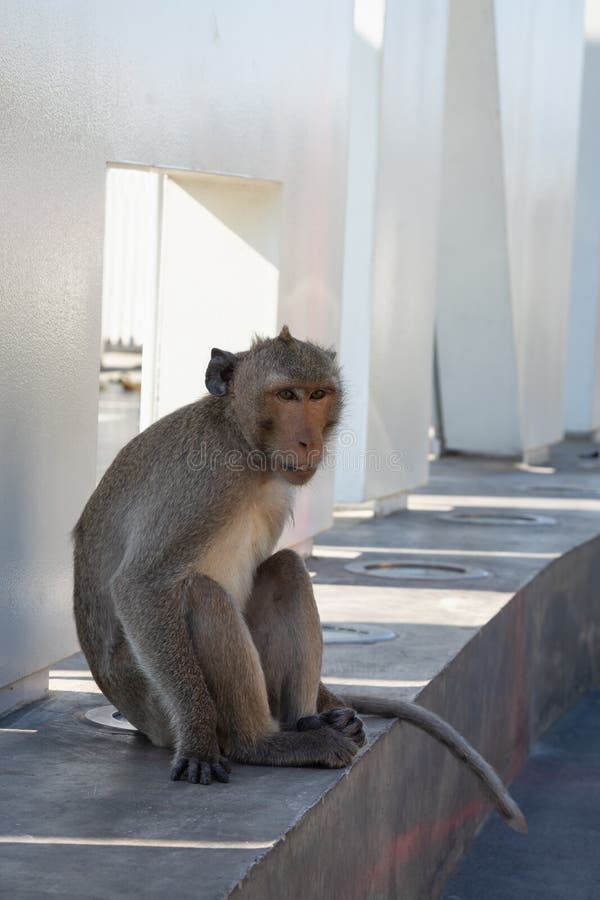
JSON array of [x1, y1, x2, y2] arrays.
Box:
[[437, 0, 520, 453]]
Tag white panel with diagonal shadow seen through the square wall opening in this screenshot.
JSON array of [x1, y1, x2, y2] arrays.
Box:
[[155, 175, 281, 418]]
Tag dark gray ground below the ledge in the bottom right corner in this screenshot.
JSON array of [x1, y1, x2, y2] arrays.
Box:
[[443, 690, 600, 900]]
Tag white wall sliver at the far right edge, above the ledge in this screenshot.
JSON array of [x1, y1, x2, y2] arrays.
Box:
[[565, 0, 600, 432]]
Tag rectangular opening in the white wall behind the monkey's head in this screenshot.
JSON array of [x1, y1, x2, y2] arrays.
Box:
[[97, 165, 281, 480]]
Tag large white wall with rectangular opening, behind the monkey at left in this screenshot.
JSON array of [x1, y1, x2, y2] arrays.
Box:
[[0, 0, 352, 704]]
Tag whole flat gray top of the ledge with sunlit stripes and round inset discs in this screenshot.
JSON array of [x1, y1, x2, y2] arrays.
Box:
[[0, 434, 600, 900]]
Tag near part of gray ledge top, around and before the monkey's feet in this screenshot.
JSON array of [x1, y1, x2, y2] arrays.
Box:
[[0, 655, 390, 900]]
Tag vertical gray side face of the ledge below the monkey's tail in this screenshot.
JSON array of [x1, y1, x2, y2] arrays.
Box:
[[237, 537, 600, 900]]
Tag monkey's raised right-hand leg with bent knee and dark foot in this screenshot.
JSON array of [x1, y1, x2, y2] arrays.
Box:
[[245, 550, 366, 746]]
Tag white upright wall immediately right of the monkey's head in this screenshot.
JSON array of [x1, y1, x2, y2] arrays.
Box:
[[336, 0, 447, 510]]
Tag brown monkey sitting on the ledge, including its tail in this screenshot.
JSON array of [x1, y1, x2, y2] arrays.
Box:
[[73, 326, 526, 831]]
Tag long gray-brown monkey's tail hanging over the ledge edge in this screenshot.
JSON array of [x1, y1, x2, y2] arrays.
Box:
[[341, 694, 527, 834]]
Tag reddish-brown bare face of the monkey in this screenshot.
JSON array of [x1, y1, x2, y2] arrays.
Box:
[[256, 380, 339, 485]]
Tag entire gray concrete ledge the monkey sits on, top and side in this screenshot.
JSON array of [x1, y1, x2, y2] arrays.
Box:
[[0, 443, 600, 900]]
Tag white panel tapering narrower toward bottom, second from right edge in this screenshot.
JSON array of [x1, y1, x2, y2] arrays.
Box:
[[496, 0, 583, 450]]
